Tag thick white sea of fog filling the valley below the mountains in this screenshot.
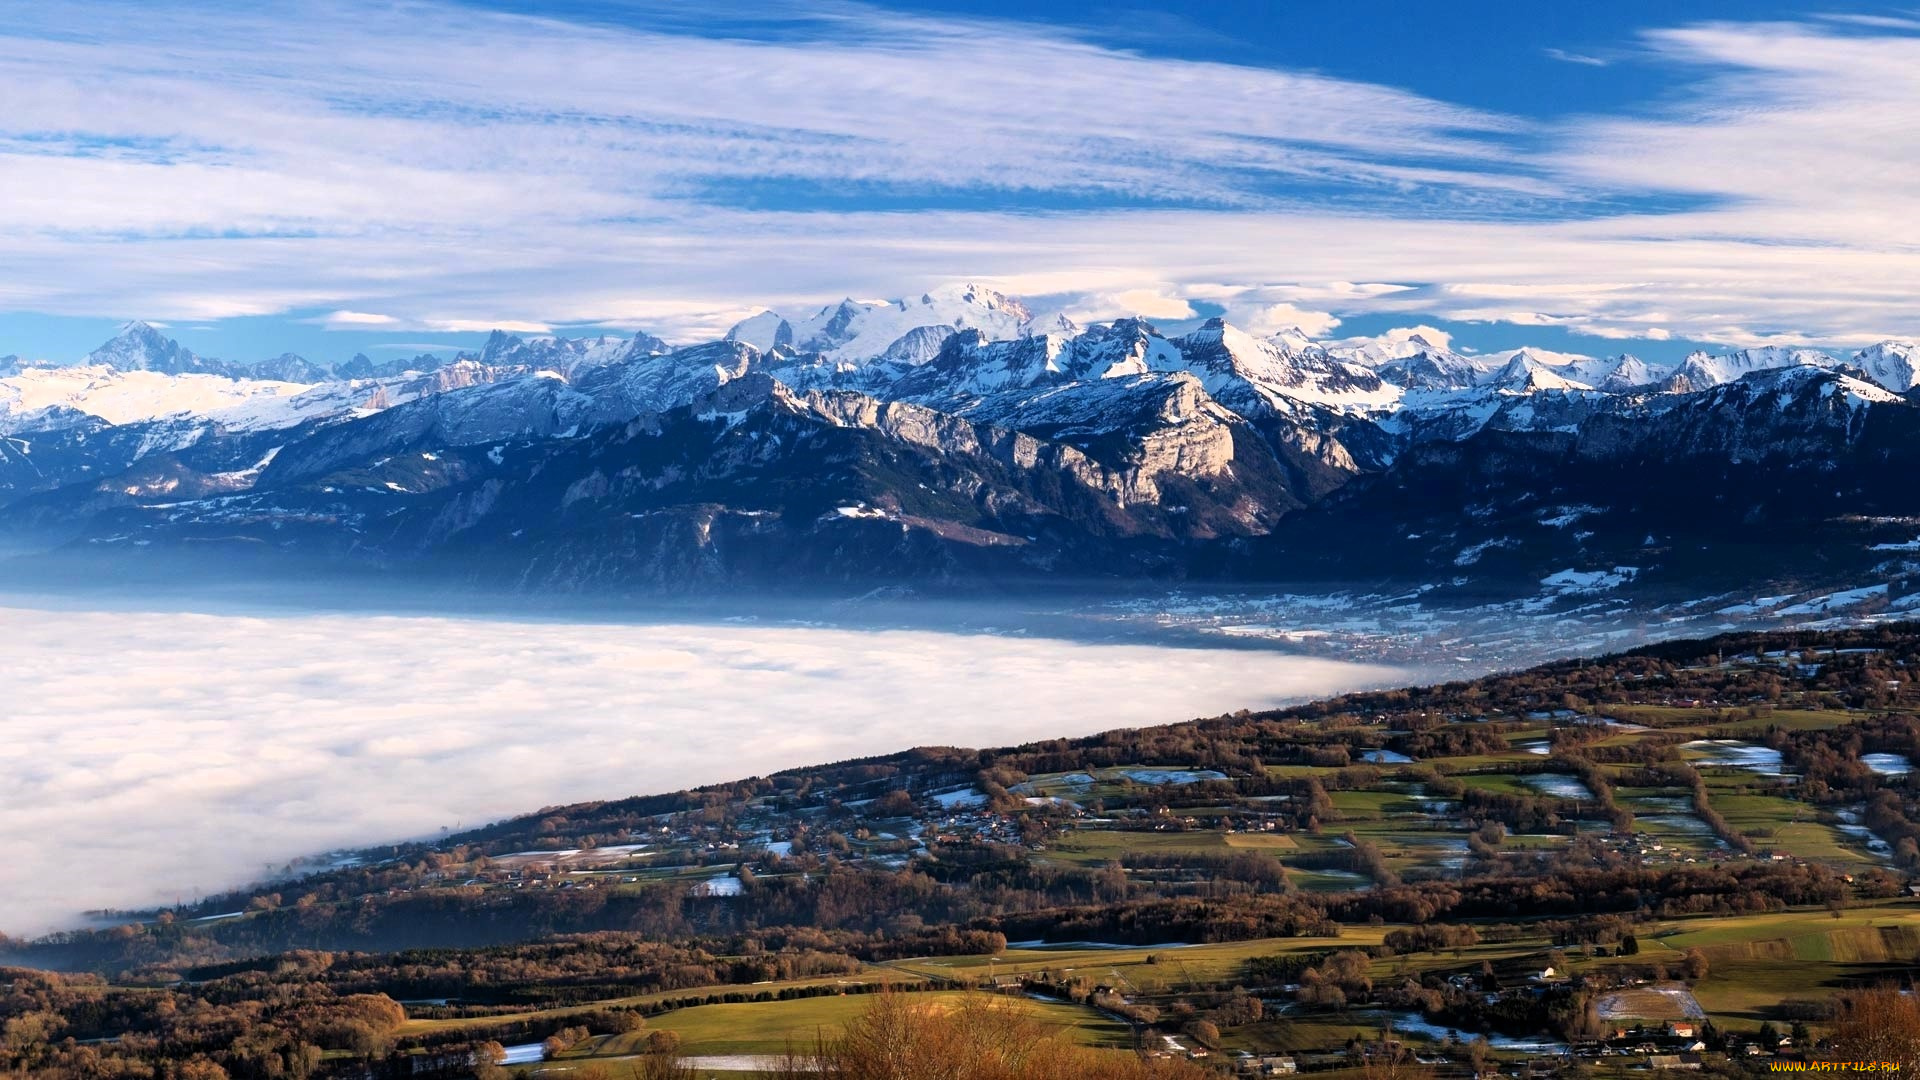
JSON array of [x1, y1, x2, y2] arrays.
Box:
[[0, 600, 1409, 934]]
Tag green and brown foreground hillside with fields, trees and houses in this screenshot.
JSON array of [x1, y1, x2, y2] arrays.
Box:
[[0, 623, 1920, 1080]]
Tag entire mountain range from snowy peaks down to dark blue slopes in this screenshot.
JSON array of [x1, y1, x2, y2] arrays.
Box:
[[0, 284, 1920, 588]]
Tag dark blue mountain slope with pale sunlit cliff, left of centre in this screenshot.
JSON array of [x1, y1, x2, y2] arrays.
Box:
[[48, 375, 1320, 588]]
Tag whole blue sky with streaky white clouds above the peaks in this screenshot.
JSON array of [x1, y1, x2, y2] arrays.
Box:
[[0, 0, 1920, 361]]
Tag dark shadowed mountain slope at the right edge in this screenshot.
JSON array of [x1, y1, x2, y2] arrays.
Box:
[[1238, 367, 1920, 596]]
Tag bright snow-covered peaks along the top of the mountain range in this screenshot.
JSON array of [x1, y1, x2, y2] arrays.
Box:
[[0, 294, 1920, 438]]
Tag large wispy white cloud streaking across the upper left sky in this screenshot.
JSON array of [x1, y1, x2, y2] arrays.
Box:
[[0, 0, 1511, 234]]
